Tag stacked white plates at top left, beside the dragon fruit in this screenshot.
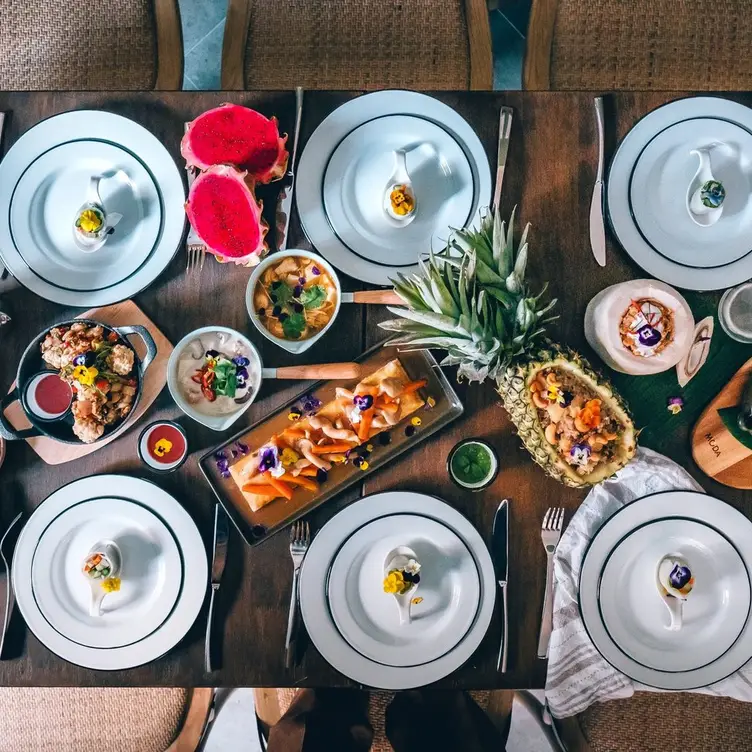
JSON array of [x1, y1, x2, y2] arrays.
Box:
[[0, 110, 185, 307]]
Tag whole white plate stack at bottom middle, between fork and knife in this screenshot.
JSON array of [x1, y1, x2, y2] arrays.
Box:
[[300, 491, 496, 690]]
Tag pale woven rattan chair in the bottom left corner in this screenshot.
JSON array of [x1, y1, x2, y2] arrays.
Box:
[[0, 687, 214, 752]]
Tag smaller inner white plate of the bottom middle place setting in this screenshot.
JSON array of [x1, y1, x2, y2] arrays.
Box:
[[328, 514, 480, 666]]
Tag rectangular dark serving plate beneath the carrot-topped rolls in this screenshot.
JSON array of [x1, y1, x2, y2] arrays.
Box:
[[199, 345, 464, 546]]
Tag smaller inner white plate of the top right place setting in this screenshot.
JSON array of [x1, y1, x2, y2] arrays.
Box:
[[630, 118, 752, 269]]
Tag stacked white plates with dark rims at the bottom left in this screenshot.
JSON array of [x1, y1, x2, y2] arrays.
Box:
[[12, 475, 208, 670]]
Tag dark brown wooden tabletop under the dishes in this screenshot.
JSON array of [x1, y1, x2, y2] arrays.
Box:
[[0, 92, 752, 689]]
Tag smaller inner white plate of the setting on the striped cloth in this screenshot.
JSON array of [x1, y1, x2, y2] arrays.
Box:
[[600, 517, 750, 671]]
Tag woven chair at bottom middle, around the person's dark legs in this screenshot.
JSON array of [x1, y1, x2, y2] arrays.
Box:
[[256, 689, 513, 752]]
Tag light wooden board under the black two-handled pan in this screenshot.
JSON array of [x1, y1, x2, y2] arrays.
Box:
[[5, 300, 173, 465]]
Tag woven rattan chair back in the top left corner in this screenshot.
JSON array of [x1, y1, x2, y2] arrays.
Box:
[[0, 0, 183, 91]]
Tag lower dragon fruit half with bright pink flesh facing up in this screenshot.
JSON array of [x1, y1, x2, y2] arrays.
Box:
[[185, 165, 269, 266]]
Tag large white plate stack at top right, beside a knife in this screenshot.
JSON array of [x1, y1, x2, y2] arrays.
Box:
[[606, 97, 752, 290]]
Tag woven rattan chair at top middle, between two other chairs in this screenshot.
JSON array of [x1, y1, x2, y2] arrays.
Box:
[[222, 0, 493, 90]]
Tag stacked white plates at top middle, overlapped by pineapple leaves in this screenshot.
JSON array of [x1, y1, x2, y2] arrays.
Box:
[[295, 91, 491, 285]]
